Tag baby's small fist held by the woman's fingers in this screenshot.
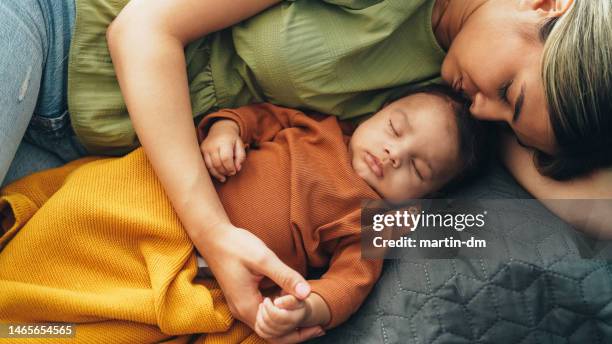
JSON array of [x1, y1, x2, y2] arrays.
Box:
[[255, 295, 308, 339]]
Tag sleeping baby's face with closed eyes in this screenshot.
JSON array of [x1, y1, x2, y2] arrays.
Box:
[[349, 93, 462, 202]]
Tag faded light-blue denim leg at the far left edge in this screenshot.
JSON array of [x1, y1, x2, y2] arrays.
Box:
[[0, 0, 47, 181]]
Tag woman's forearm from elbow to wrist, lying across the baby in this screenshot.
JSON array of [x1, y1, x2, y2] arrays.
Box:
[[109, 19, 229, 246]]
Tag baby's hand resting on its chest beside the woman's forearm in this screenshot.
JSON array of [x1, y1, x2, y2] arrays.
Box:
[[200, 119, 246, 182]]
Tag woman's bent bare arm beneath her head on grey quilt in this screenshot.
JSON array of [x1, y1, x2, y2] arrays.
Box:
[[502, 133, 612, 239]]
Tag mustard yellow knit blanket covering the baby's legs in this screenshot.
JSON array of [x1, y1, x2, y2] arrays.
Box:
[[0, 149, 263, 343]]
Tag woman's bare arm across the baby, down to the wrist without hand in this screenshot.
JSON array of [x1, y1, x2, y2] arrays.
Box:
[[107, 0, 276, 246]]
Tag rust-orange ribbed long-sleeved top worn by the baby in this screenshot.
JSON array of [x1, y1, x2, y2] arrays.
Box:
[[198, 104, 382, 327]]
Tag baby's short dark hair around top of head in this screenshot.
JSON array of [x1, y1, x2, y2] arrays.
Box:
[[396, 84, 489, 191]]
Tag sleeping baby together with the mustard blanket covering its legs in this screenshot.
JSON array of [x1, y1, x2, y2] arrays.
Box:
[[0, 87, 484, 343]]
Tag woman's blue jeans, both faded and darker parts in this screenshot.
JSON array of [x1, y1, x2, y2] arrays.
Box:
[[0, 0, 86, 184]]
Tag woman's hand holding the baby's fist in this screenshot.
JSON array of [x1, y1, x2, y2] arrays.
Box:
[[196, 225, 321, 343]]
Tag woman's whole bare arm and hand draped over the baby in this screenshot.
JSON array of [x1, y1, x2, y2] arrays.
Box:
[[107, 0, 318, 338]]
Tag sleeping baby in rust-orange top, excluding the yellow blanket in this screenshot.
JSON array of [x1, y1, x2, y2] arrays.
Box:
[[198, 86, 484, 339]]
